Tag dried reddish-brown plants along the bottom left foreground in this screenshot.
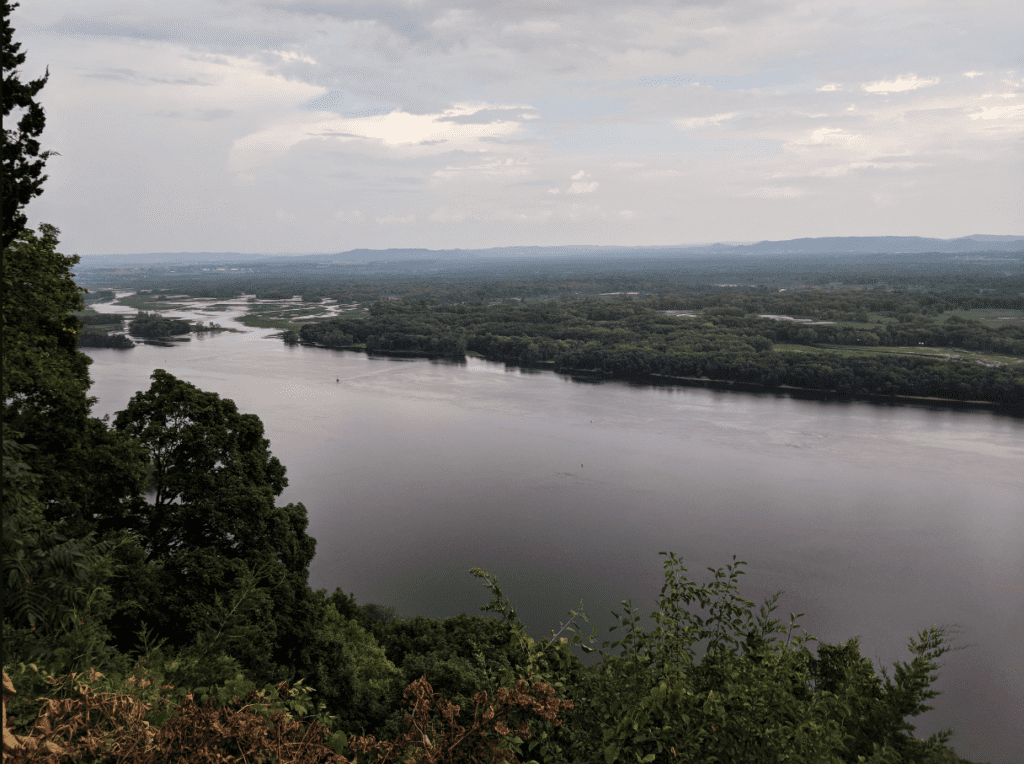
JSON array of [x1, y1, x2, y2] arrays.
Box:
[[3, 669, 572, 764]]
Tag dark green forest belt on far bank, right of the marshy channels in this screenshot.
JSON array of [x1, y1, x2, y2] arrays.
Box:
[[292, 295, 1024, 408]]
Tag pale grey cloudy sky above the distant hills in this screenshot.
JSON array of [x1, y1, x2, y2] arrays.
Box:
[[13, 0, 1024, 254]]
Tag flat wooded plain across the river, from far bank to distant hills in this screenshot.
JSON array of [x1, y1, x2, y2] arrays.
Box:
[[72, 240, 1024, 412]]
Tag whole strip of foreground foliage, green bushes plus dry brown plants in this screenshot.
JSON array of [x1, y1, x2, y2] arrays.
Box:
[[2, 553, 983, 764]]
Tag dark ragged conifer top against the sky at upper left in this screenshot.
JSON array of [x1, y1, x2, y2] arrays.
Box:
[[0, 0, 59, 251]]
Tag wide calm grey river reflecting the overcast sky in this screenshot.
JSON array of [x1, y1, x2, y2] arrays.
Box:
[[86, 292, 1024, 762]]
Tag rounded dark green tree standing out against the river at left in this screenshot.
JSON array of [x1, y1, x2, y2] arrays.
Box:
[[107, 369, 325, 681]]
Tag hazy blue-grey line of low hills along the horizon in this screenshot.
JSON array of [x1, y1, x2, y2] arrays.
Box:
[[78, 234, 1024, 269]]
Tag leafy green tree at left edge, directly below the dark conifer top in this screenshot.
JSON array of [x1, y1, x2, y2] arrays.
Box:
[[0, 223, 145, 537]]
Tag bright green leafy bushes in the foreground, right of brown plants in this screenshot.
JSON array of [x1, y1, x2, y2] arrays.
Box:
[[462, 552, 974, 764]]
